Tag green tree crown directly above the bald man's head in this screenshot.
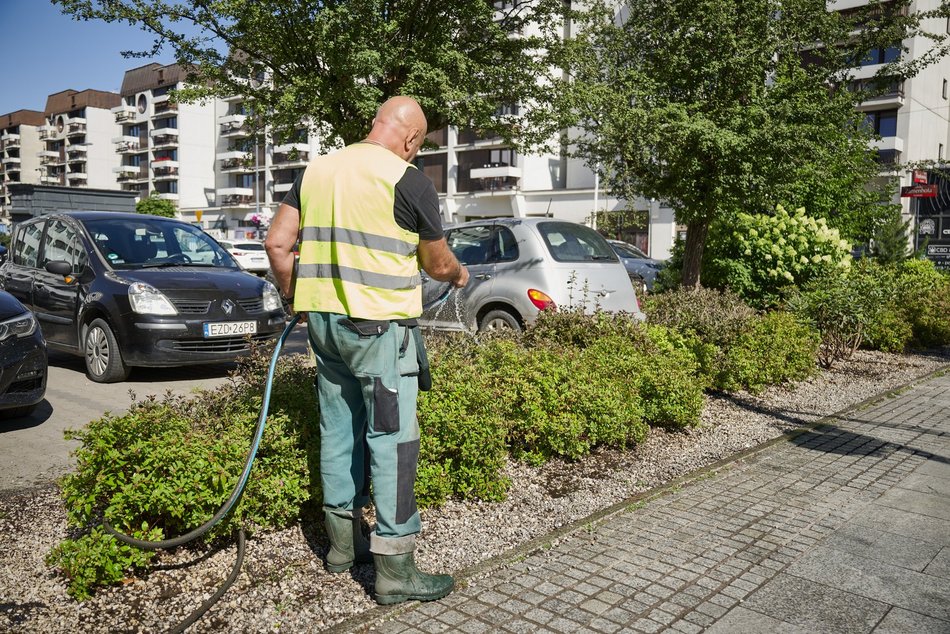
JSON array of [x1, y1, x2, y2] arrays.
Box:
[[53, 0, 565, 143]]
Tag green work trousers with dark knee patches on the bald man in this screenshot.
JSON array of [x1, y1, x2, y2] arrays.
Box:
[[307, 312, 421, 540]]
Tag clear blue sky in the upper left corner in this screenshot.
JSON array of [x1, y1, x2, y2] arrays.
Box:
[[0, 0, 181, 115]]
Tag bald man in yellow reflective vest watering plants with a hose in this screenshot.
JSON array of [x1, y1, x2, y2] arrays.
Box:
[[265, 97, 468, 604]]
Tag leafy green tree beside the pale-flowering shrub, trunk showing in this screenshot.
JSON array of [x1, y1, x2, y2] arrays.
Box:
[[558, 0, 947, 286]]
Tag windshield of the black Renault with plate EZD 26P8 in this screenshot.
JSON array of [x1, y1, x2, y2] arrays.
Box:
[[83, 216, 240, 269]]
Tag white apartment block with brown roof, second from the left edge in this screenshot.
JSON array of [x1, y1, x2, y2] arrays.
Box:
[[38, 90, 119, 189]]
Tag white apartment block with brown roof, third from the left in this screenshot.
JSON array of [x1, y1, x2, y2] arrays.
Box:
[[111, 63, 216, 208]]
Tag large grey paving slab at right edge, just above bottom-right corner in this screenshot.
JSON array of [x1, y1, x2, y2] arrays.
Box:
[[787, 546, 950, 620]]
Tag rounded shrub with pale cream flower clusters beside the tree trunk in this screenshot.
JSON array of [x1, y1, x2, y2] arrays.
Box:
[[702, 205, 851, 307]]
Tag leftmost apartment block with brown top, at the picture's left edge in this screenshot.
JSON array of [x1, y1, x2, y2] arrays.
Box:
[[0, 110, 46, 217]]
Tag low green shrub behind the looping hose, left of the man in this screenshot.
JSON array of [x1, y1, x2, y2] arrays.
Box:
[[47, 346, 317, 598]]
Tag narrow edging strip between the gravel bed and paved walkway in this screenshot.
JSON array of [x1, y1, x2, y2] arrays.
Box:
[[324, 363, 950, 634]]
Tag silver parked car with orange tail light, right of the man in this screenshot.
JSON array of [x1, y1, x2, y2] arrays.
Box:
[[420, 218, 643, 331]]
